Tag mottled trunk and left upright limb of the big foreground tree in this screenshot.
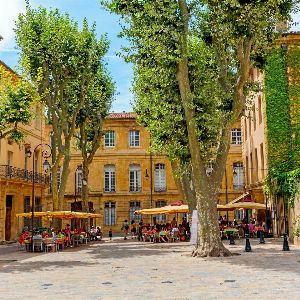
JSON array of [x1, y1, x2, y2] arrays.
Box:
[[176, 0, 230, 257]]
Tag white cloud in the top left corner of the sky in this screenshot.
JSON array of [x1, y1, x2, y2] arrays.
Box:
[[0, 0, 25, 50]]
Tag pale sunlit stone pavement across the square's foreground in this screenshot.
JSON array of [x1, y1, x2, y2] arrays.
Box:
[[0, 238, 300, 300]]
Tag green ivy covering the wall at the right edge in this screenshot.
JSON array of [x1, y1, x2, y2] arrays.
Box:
[[265, 45, 300, 206]]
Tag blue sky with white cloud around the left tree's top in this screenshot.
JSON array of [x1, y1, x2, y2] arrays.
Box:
[[0, 0, 133, 112]]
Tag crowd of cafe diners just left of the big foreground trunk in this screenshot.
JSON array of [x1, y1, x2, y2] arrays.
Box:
[[122, 217, 190, 243]]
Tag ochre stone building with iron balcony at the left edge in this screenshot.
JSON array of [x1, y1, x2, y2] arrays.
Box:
[[0, 61, 47, 241]]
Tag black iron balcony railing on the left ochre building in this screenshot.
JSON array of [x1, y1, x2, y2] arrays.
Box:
[[0, 165, 49, 184]]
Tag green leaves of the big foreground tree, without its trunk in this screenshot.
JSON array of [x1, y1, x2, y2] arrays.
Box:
[[101, 0, 291, 171]]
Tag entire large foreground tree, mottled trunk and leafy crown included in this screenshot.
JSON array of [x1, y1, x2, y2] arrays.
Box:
[[102, 0, 298, 256]]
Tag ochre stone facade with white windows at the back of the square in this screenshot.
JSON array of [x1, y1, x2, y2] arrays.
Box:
[[46, 112, 244, 232]]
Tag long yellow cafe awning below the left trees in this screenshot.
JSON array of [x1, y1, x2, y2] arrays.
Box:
[[16, 211, 102, 219]]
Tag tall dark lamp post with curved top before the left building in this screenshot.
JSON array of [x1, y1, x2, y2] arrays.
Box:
[[26, 143, 52, 235]]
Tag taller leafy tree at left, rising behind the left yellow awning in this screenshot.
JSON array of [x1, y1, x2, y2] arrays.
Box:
[[15, 2, 115, 210]]
